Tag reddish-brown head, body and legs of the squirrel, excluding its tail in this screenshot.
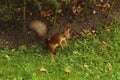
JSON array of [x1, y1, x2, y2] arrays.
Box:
[[48, 29, 70, 55]]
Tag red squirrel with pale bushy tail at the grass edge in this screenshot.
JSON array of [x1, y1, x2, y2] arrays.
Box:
[[30, 20, 71, 56]]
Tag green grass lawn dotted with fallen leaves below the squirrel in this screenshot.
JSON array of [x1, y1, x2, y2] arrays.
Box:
[[0, 19, 120, 80]]
